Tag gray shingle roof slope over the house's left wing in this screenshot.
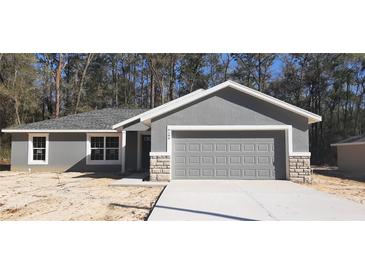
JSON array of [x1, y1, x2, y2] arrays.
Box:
[[9, 108, 148, 130]]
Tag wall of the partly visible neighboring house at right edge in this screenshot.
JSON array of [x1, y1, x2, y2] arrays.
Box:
[[337, 145, 365, 173]]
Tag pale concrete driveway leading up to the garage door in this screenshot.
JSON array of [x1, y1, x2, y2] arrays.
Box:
[[148, 180, 365, 221]]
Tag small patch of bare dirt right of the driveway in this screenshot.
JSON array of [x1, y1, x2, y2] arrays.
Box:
[[307, 167, 365, 204]]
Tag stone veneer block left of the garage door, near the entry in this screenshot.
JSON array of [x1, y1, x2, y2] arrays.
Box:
[[150, 155, 171, 182]]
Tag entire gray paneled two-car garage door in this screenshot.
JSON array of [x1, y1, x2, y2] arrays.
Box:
[[172, 131, 286, 179]]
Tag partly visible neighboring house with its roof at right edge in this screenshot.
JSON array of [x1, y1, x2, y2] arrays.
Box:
[[331, 134, 365, 173]]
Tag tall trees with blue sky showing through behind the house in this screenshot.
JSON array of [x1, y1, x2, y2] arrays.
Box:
[[0, 53, 365, 163]]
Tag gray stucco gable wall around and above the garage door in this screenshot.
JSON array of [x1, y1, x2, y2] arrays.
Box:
[[151, 88, 309, 152]]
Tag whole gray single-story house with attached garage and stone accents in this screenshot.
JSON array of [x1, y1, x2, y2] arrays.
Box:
[[3, 81, 321, 182]]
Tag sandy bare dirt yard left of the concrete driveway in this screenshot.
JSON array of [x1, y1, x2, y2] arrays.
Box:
[[0, 171, 163, 221]]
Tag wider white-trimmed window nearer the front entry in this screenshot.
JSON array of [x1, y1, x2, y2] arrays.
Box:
[[86, 133, 121, 165]]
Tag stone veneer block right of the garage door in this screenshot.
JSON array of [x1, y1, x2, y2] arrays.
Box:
[[289, 156, 312, 183]]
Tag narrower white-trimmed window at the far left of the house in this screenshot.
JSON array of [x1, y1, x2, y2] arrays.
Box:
[[28, 133, 49, 165]]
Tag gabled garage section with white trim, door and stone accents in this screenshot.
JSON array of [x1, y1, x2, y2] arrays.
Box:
[[140, 81, 321, 182]]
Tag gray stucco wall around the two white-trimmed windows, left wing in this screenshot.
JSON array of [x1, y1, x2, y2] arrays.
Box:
[[11, 133, 121, 172]]
